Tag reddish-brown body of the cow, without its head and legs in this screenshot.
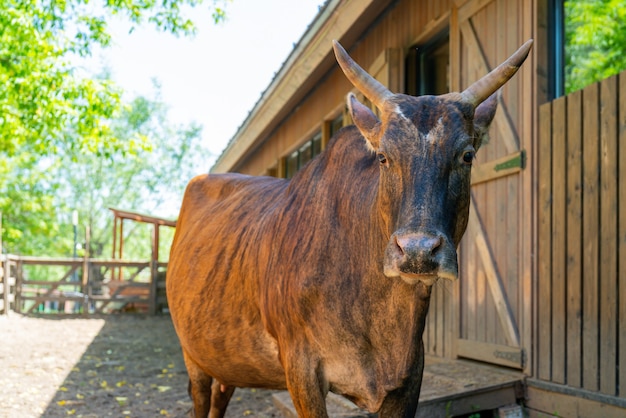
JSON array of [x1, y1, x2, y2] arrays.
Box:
[[169, 127, 430, 410]]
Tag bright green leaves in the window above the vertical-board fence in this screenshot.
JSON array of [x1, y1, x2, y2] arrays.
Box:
[[564, 0, 626, 93]]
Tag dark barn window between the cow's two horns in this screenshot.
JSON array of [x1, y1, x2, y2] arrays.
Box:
[[406, 31, 450, 96]]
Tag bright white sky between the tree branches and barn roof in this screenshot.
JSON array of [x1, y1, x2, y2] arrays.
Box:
[[91, 0, 323, 170]]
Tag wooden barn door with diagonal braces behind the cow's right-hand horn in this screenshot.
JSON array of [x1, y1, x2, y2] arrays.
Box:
[[451, 0, 531, 369]]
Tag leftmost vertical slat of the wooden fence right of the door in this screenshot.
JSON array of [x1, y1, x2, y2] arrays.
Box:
[[535, 103, 552, 380]]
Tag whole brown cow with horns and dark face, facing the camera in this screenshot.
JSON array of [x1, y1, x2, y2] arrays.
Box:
[[167, 41, 532, 418]]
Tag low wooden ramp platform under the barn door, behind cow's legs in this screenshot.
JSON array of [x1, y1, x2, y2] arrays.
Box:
[[273, 356, 524, 418]]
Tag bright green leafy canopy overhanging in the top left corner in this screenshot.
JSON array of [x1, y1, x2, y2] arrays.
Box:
[[0, 0, 224, 157]]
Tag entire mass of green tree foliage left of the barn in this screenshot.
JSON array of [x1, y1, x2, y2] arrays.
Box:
[[0, 0, 228, 255]]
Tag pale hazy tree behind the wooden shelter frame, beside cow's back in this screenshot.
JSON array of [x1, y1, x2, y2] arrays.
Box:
[[53, 86, 209, 258]]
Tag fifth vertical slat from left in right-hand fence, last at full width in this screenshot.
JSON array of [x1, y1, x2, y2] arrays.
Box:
[[598, 76, 618, 395]]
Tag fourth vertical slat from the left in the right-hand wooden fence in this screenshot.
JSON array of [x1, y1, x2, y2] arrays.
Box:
[[582, 84, 600, 391]]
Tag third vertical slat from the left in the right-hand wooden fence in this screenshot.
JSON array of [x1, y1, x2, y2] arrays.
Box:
[[566, 91, 582, 387]]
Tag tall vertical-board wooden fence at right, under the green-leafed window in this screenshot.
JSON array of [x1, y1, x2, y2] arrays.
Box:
[[535, 72, 626, 398]]
